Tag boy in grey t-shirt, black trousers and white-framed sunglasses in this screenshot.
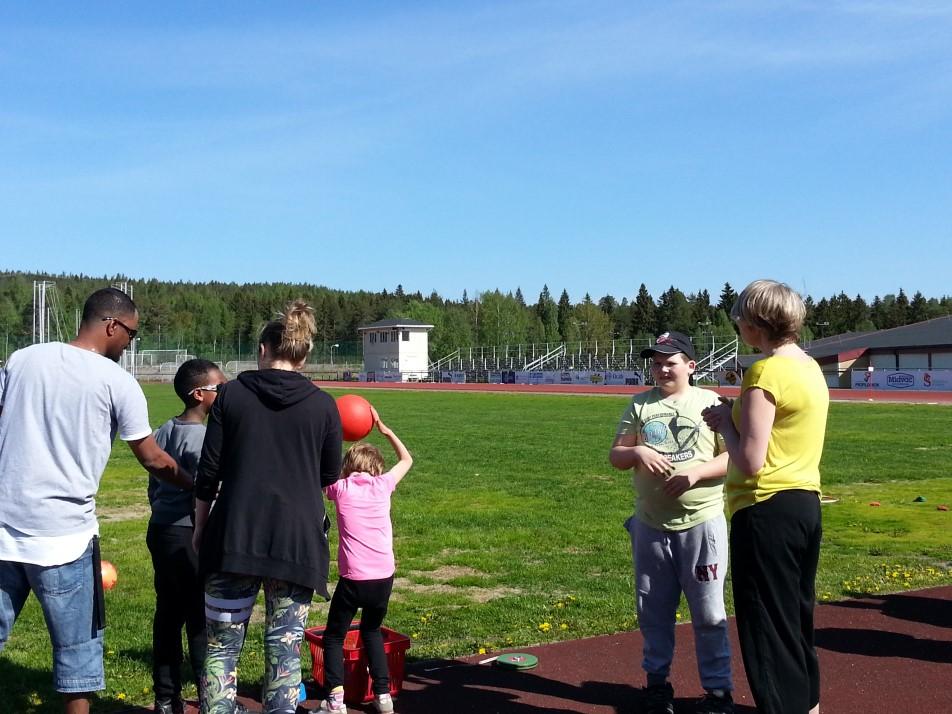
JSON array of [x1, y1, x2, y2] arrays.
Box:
[[146, 359, 226, 714]]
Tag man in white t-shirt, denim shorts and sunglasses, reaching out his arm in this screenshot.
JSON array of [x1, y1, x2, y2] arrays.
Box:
[[0, 288, 192, 714]]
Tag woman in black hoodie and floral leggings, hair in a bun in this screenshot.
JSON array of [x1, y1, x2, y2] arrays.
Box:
[[194, 300, 341, 714]]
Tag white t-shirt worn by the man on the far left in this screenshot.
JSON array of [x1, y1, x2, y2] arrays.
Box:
[[0, 342, 152, 562]]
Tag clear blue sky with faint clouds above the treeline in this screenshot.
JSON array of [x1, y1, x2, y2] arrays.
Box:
[[0, 0, 952, 301]]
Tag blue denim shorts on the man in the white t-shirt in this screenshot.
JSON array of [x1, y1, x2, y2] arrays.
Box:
[[0, 542, 106, 694]]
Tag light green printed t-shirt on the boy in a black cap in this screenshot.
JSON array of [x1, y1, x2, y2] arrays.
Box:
[[618, 387, 724, 531]]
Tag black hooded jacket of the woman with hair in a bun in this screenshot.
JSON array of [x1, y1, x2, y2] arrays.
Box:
[[195, 369, 341, 598]]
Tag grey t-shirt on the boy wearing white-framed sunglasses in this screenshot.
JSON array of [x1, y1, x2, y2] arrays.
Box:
[[149, 417, 205, 526]]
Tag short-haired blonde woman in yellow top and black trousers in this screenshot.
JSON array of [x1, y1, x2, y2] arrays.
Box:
[[704, 280, 830, 714]]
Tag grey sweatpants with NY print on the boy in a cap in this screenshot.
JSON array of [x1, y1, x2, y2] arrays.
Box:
[[626, 515, 734, 690]]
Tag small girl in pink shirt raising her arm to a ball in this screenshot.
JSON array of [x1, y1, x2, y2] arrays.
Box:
[[319, 410, 413, 712]]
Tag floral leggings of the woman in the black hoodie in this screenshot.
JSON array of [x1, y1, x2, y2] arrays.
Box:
[[201, 573, 314, 714]]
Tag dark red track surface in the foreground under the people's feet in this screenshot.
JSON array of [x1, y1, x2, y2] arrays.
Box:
[[143, 586, 952, 714]]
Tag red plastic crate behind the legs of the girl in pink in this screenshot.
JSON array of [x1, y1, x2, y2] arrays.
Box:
[[304, 623, 410, 704]]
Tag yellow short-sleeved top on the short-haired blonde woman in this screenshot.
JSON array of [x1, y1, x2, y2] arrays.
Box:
[[724, 355, 830, 515]]
